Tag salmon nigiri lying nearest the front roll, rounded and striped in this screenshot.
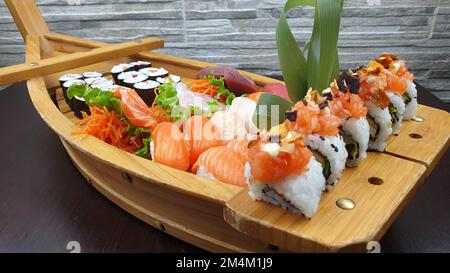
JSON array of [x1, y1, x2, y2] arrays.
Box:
[[192, 146, 247, 187]]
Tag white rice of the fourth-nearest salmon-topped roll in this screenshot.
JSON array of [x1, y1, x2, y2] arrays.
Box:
[[364, 101, 392, 152]]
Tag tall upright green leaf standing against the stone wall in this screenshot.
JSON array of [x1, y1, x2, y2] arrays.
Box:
[[276, 0, 343, 101]]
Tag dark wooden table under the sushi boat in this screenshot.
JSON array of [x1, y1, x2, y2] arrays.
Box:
[[0, 83, 450, 252]]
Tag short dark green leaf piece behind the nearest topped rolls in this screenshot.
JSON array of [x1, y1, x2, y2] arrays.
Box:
[[253, 93, 292, 130]]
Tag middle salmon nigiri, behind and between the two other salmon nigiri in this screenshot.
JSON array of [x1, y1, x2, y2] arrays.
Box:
[[183, 116, 224, 165]]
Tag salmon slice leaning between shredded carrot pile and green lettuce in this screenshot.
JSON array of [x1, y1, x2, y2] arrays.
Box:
[[113, 86, 158, 130]]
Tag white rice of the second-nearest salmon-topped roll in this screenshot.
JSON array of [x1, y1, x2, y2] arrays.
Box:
[[304, 134, 348, 190]]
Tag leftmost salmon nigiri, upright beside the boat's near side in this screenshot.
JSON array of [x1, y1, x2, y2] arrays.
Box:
[[151, 122, 190, 171]]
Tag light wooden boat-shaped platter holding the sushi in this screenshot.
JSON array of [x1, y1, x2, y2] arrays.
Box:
[[0, 0, 450, 252]]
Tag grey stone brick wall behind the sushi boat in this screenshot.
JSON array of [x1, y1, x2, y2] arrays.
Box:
[[0, 0, 450, 102]]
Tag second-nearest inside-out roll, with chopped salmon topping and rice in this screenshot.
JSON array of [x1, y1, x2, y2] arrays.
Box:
[[286, 90, 348, 190]]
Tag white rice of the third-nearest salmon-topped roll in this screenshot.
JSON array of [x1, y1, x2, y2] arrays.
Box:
[[341, 117, 370, 167]]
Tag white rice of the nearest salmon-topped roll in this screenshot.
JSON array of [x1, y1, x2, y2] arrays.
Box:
[[246, 157, 325, 218]]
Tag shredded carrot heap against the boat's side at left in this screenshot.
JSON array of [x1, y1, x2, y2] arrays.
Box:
[[72, 107, 142, 152]]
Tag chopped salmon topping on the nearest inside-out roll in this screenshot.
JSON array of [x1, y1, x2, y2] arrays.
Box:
[[248, 140, 312, 183]]
